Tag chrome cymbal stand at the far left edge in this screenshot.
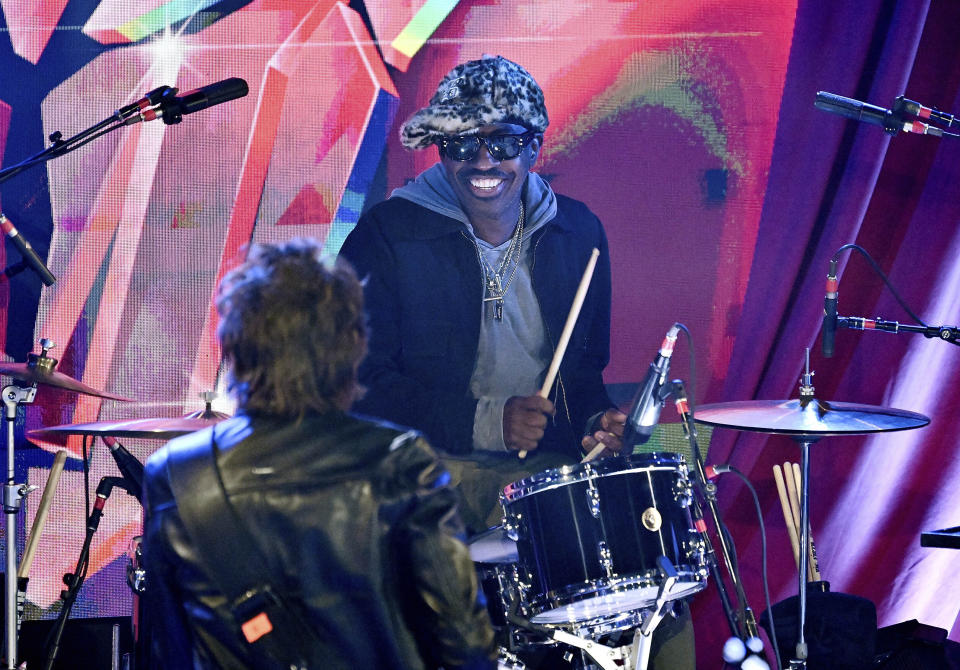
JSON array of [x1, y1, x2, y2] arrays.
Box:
[[3, 384, 37, 670]]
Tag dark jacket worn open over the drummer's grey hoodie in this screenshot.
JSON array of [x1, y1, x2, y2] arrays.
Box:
[[340, 195, 613, 460]]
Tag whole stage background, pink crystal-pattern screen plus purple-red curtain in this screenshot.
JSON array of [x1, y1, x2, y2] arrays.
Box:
[[0, 0, 960, 662]]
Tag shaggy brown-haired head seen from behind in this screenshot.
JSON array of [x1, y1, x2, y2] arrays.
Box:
[[217, 239, 366, 416]]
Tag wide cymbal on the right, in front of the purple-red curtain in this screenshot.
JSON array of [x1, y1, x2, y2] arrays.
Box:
[[694, 398, 930, 437]]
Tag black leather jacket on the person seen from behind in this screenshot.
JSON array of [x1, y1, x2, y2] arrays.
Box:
[[142, 412, 496, 670]]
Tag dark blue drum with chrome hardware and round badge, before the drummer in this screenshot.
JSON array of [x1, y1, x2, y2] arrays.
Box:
[[500, 453, 707, 624]]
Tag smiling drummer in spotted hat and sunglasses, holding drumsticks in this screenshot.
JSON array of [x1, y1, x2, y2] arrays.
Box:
[[341, 56, 626, 531]]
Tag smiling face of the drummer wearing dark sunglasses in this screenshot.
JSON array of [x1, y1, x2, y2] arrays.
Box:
[[440, 123, 540, 243]]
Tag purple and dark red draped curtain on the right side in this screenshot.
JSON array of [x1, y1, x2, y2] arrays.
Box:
[[694, 1, 960, 662]]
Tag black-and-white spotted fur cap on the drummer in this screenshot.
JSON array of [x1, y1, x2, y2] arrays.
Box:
[[400, 55, 550, 149]]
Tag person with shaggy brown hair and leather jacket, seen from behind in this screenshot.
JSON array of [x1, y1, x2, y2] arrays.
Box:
[[144, 239, 496, 670]]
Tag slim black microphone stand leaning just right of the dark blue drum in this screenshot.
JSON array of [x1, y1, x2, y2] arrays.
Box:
[[672, 379, 758, 640]]
